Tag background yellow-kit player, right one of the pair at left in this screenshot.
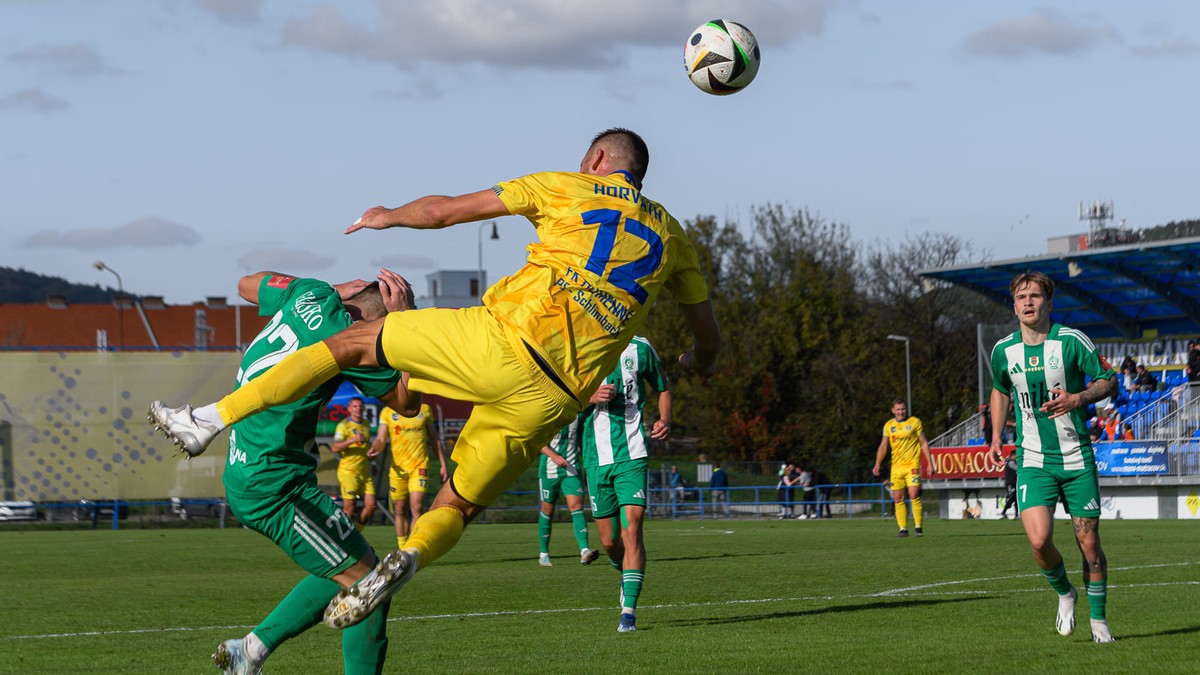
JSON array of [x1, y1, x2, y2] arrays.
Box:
[[371, 404, 450, 549]]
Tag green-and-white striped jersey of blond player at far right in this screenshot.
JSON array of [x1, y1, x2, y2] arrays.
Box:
[[991, 323, 1116, 471]]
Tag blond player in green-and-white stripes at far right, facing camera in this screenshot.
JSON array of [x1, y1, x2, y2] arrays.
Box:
[[990, 271, 1116, 643]]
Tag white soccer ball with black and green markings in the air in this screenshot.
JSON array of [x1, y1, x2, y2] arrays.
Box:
[[683, 19, 760, 96]]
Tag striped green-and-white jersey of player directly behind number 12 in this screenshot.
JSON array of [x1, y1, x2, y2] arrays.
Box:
[[583, 336, 667, 468]]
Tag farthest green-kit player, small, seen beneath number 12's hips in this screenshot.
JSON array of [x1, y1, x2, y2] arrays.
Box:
[[538, 414, 600, 567]]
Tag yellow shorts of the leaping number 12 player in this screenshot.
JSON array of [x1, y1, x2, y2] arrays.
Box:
[[380, 306, 580, 506]]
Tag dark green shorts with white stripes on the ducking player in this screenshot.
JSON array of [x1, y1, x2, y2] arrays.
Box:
[[226, 476, 371, 579]]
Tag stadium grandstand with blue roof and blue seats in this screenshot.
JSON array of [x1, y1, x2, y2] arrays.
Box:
[[919, 235, 1200, 518]]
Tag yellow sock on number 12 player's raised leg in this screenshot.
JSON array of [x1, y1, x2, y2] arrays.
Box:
[[217, 342, 341, 425]]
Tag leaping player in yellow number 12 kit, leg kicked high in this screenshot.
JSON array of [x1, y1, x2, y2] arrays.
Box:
[[142, 129, 721, 628]]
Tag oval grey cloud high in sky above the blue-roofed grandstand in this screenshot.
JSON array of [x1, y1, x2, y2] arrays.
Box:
[[962, 10, 1118, 58]]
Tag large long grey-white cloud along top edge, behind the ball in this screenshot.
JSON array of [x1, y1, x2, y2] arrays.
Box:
[[282, 0, 856, 70]]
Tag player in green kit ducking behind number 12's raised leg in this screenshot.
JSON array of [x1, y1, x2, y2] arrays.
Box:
[[150, 265, 420, 675]]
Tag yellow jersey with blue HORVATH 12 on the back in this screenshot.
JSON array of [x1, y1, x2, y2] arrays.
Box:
[[484, 172, 708, 401]]
